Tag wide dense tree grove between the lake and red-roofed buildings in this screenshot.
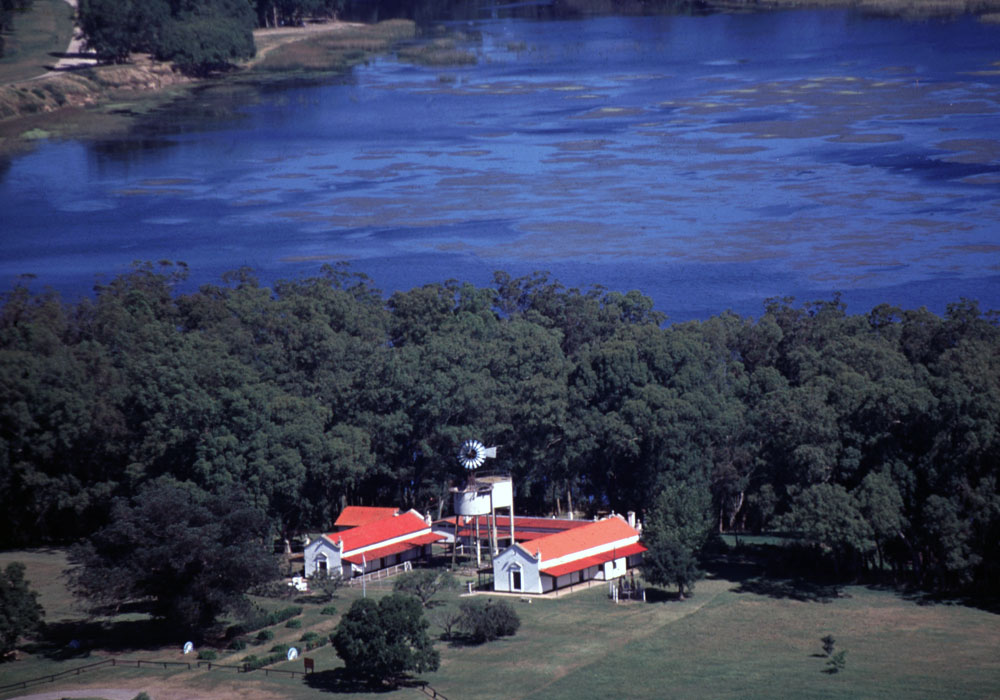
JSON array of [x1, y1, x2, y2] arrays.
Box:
[[0, 264, 1000, 591]]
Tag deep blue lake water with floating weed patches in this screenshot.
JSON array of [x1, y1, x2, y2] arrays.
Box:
[[0, 10, 1000, 320]]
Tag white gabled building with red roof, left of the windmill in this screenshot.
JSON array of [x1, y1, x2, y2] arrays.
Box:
[[305, 510, 442, 579]]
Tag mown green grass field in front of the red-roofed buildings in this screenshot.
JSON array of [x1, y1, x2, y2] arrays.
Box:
[[0, 551, 1000, 700]]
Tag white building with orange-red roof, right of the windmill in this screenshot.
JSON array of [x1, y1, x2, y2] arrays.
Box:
[[493, 515, 646, 593]]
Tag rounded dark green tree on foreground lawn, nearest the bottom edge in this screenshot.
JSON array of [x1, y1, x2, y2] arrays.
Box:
[[330, 593, 440, 684]]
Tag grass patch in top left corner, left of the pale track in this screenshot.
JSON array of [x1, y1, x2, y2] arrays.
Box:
[[0, 0, 73, 85]]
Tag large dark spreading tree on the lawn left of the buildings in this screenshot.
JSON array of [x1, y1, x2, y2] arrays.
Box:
[[72, 477, 277, 631]]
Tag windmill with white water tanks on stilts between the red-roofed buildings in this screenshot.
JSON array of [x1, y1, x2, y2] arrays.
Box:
[[451, 440, 514, 566]]
